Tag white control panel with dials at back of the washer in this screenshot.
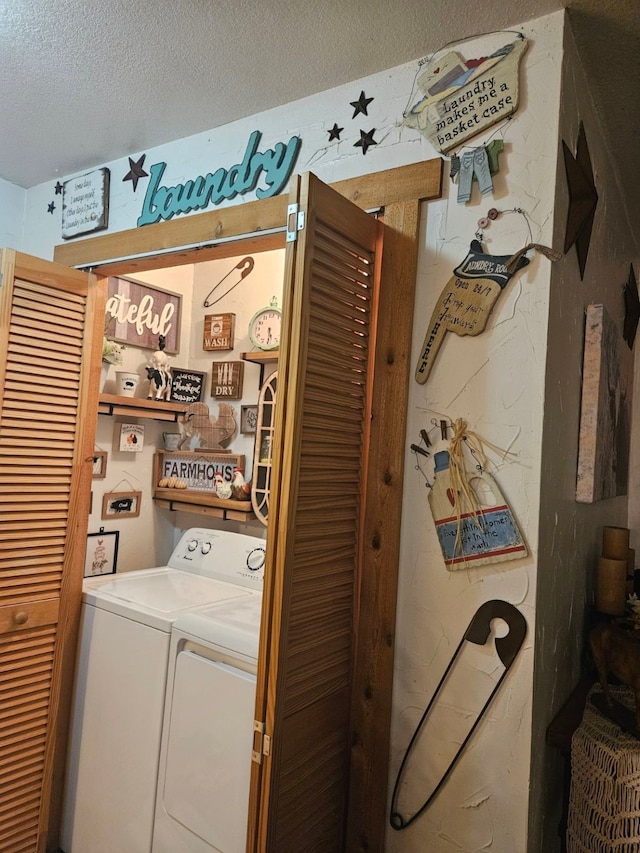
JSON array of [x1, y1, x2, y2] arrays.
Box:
[[168, 527, 266, 589]]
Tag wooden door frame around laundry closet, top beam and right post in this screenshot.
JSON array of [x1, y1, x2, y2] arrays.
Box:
[[54, 159, 443, 853]]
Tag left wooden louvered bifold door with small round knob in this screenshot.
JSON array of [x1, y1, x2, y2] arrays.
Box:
[[0, 250, 103, 853]]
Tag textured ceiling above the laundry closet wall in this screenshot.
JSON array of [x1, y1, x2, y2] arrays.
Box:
[[0, 0, 640, 230]]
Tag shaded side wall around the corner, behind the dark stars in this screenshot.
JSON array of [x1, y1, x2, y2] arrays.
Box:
[[529, 18, 640, 851]]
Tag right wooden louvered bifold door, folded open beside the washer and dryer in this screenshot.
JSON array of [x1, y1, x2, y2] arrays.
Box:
[[249, 175, 382, 853]]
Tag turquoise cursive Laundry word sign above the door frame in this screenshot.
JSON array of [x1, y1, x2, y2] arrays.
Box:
[[137, 130, 301, 226]]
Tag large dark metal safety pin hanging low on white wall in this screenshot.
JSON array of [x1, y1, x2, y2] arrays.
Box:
[[389, 599, 527, 830]]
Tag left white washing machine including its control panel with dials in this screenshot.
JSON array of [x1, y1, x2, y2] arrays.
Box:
[[61, 528, 265, 853]]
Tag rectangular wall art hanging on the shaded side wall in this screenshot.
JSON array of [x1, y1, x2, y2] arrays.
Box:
[[576, 305, 633, 503]]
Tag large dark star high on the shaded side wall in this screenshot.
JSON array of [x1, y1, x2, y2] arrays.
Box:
[[562, 122, 598, 279]]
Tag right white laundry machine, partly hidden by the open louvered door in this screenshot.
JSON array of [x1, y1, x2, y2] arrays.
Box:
[[153, 584, 262, 853]]
